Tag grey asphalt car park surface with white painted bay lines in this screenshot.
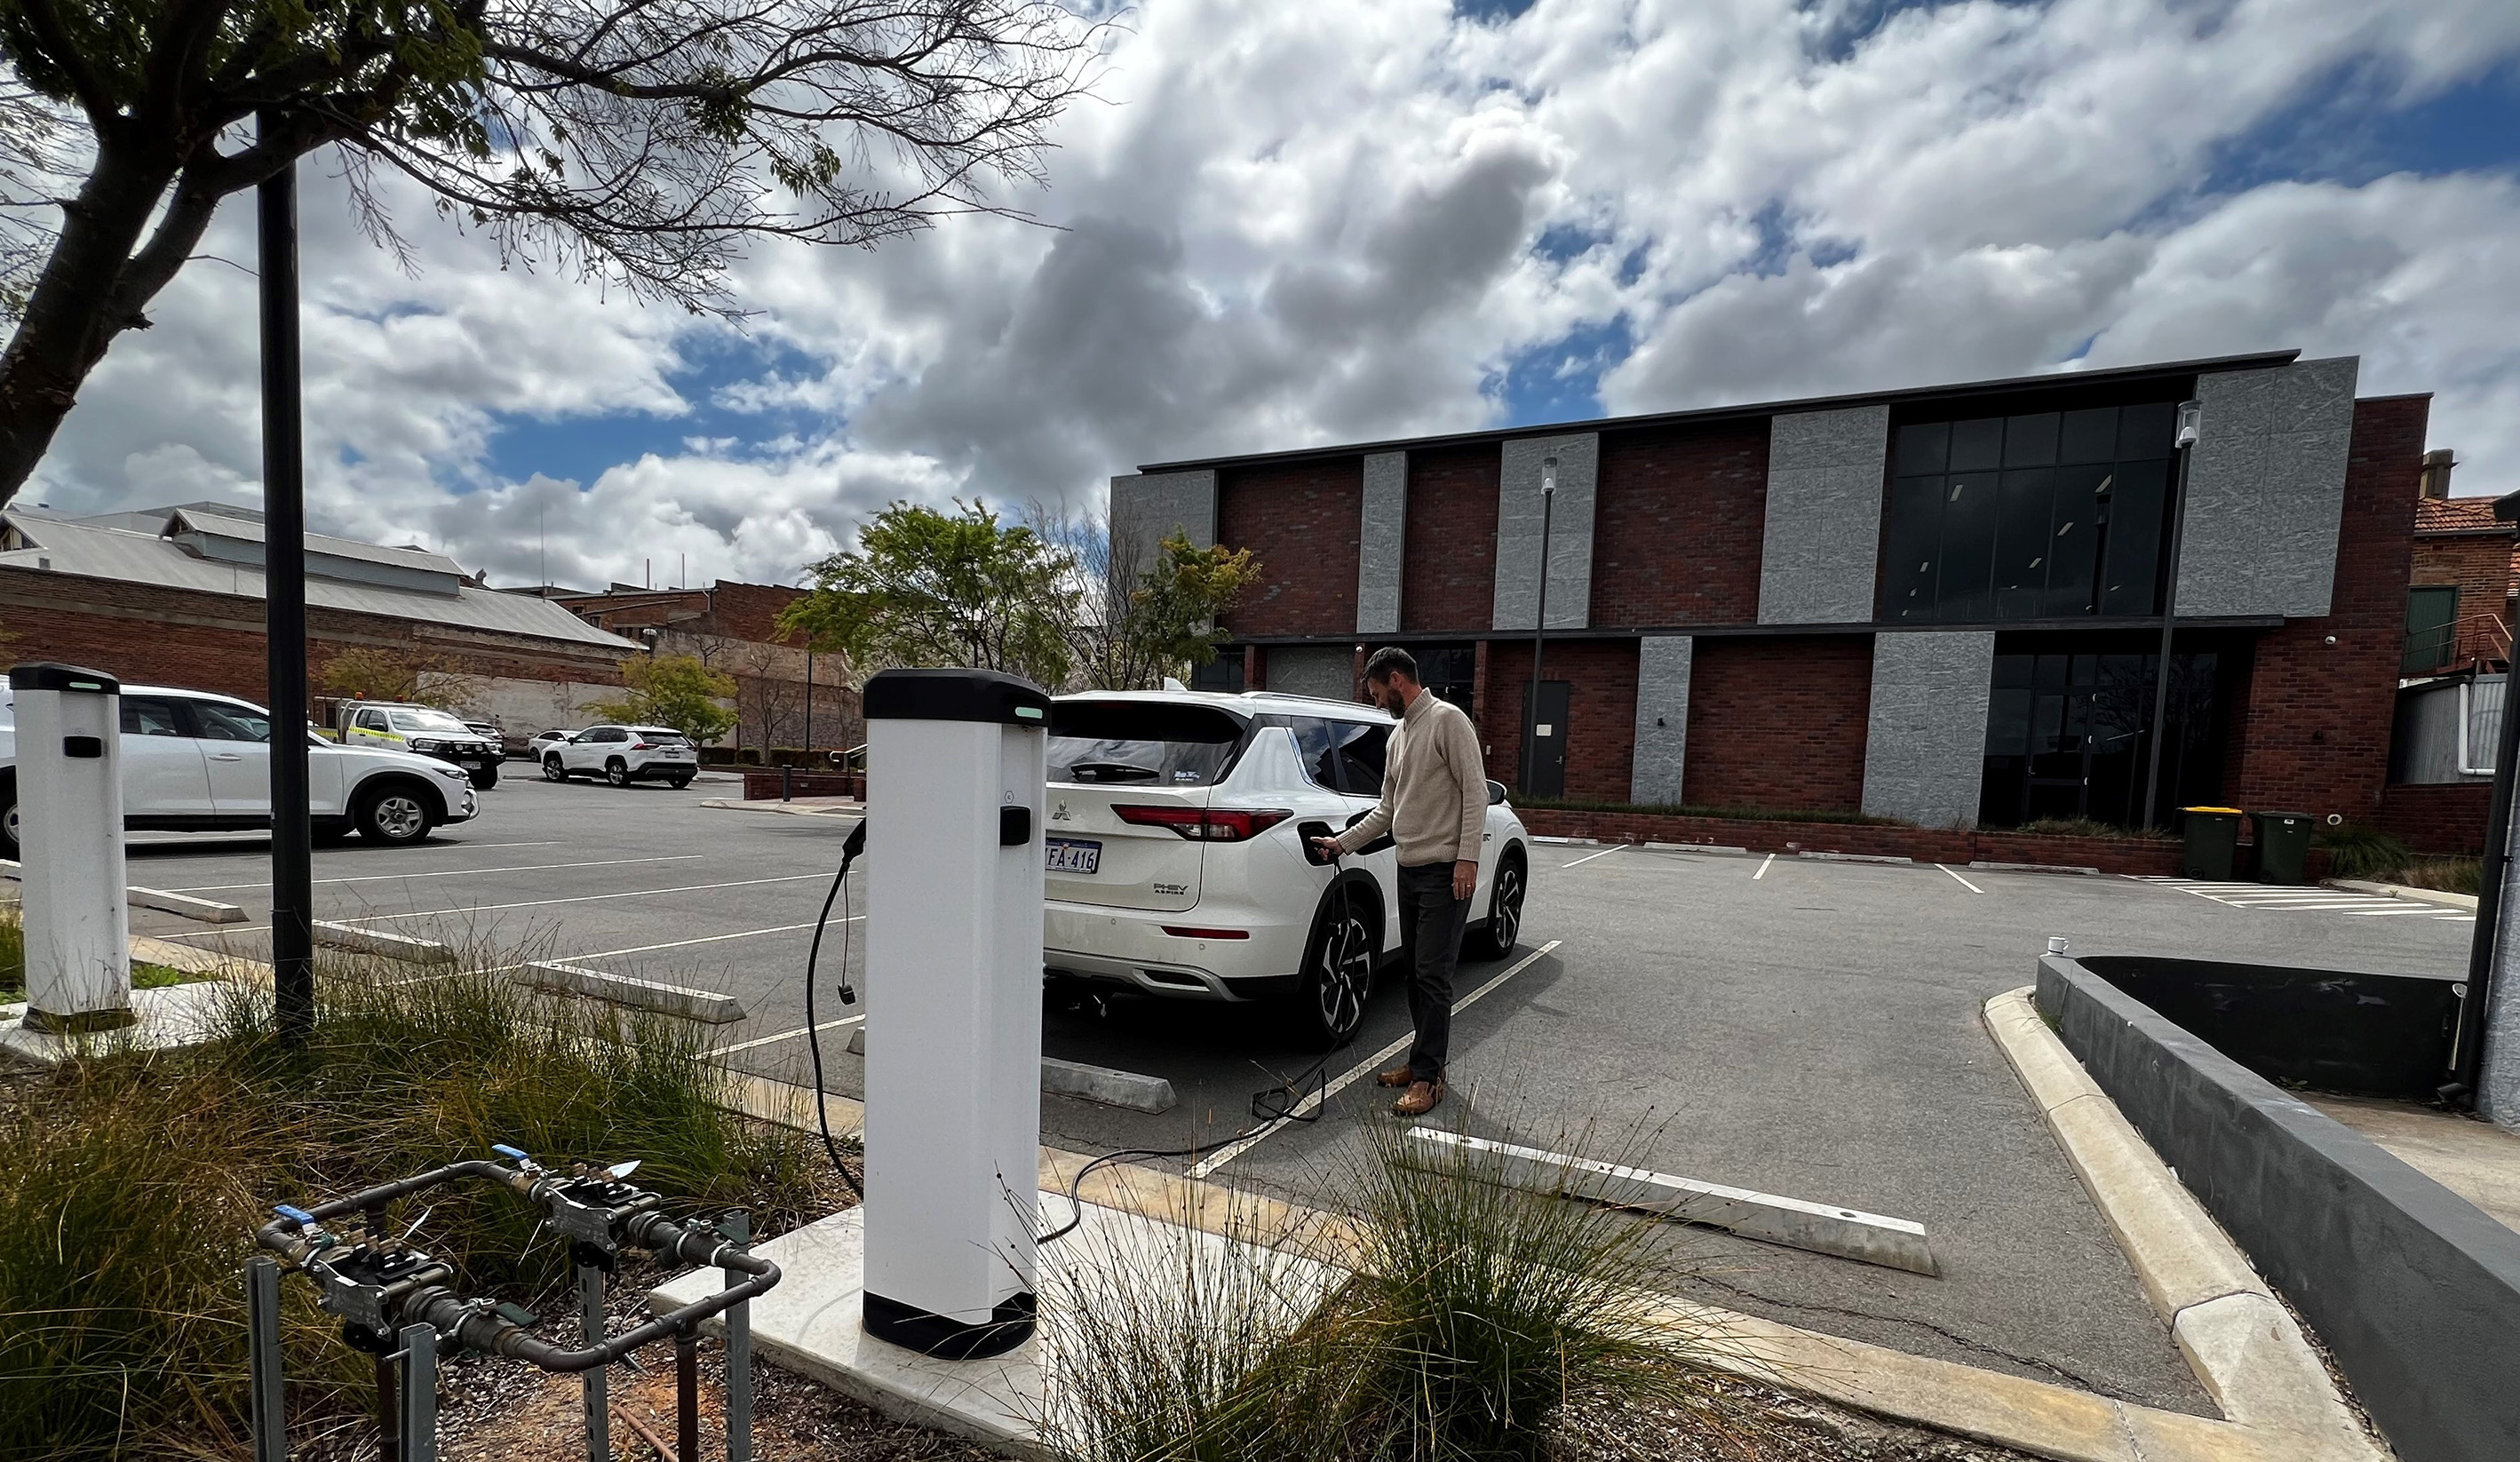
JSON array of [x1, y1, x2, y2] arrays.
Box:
[[131, 776, 2472, 1411]]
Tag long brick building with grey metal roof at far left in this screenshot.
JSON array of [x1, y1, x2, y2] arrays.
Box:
[[0, 502, 640, 726]]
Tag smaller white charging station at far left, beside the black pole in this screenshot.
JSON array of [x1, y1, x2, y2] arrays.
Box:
[[8, 661, 136, 1031]]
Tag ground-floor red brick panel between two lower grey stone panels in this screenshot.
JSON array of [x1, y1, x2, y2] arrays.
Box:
[[1681, 635, 1872, 812]]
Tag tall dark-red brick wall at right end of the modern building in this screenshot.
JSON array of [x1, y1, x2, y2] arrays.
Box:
[[2238, 396, 2432, 822]]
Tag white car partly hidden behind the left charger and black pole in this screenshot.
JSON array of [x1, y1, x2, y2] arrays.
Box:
[[0, 676, 476, 857]]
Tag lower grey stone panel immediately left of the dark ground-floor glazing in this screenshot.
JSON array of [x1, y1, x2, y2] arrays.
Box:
[[1864, 630, 1996, 827]]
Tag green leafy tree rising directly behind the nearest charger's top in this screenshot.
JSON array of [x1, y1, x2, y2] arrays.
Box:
[[779, 499, 1076, 688]]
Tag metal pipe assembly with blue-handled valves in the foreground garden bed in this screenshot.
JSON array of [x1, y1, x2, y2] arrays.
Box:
[[244, 1147, 779, 1462]]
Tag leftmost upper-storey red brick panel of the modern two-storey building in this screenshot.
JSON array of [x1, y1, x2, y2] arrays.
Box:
[[1217, 457, 1366, 635]]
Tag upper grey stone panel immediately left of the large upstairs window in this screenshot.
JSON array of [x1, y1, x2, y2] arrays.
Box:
[[1759, 406, 1890, 625]]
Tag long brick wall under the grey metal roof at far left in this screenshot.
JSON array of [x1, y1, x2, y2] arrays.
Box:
[[0, 569, 620, 703]]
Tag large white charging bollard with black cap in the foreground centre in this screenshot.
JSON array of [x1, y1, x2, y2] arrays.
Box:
[[864, 671, 1051, 1359]]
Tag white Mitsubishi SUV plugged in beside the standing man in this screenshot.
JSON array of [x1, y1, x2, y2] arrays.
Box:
[[1044, 691, 1530, 1044]]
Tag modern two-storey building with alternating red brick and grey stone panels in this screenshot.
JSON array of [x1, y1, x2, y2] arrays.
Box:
[[1111, 350, 2429, 827]]
